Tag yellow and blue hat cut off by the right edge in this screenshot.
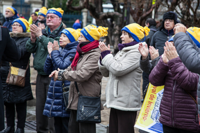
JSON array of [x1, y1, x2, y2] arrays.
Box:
[[187, 27, 200, 48]]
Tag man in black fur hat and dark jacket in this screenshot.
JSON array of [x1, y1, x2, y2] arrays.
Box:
[[150, 11, 178, 55]]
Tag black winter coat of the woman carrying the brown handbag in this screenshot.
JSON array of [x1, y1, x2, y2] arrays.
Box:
[[1, 33, 33, 103]]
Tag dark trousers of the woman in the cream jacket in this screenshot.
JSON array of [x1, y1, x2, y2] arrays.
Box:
[[109, 108, 137, 133]]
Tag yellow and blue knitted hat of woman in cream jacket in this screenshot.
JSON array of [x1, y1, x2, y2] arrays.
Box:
[[122, 23, 150, 42]]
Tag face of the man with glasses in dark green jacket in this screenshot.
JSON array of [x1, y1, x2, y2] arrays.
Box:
[[46, 13, 62, 26]]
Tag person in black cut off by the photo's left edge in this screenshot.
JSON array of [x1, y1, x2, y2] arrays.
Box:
[[0, 27, 20, 131]]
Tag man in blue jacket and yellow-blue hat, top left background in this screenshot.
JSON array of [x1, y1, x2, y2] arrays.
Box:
[[3, 7, 18, 32]]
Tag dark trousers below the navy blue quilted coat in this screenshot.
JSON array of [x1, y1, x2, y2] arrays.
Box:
[[54, 117, 69, 133]]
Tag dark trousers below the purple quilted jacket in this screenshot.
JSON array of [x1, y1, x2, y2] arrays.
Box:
[[163, 125, 194, 133]]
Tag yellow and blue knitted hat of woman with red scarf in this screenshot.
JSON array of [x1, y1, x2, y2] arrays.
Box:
[[81, 25, 108, 42]]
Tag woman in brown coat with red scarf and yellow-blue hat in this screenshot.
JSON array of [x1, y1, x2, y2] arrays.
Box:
[[50, 25, 108, 133]]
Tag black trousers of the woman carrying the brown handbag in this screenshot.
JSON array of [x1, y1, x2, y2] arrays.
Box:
[[4, 101, 26, 129]]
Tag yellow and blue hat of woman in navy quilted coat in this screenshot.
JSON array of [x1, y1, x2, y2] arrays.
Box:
[[61, 28, 81, 42]]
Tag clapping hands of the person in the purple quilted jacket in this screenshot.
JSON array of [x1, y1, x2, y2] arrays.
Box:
[[164, 41, 178, 60]]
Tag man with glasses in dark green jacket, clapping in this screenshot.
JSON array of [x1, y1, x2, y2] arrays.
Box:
[[26, 8, 64, 133]]
